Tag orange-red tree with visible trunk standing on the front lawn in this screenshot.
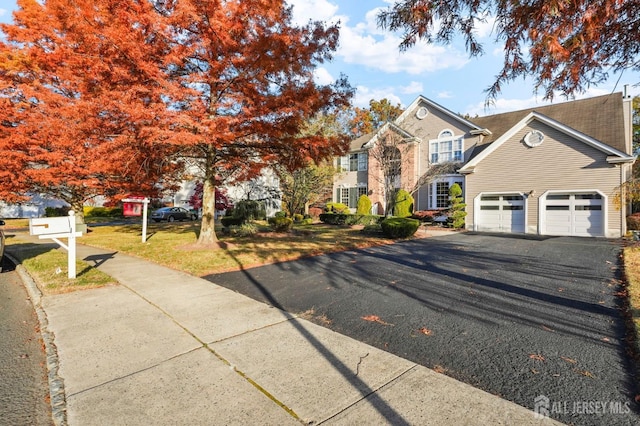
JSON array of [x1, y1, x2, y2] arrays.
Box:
[[159, 0, 353, 244]]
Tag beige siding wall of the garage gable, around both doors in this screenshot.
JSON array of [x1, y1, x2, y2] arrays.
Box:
[[466, 121, 621, 236]]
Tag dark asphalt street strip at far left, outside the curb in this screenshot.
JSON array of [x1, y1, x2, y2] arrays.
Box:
[[0, 258, 53, 426]]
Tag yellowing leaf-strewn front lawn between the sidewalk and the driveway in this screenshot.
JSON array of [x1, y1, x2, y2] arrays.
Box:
[[77, 222, 392, 276]]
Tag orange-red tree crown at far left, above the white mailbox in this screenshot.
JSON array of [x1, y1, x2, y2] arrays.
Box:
[[0, 0, 178, 217]]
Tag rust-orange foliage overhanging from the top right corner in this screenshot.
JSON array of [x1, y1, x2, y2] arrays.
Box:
[[378, 0, 640, 98]]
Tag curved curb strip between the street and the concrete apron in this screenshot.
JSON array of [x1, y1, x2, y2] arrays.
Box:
[[4, 251, 67, 426]]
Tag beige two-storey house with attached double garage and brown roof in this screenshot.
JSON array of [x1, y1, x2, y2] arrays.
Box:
[[334, 93, 635, 237]]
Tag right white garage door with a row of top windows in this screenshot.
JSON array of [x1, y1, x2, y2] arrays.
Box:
[[544, 193, 604, 237]]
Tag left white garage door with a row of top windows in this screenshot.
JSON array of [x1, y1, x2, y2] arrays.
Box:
[[477, 195, 525, 233]]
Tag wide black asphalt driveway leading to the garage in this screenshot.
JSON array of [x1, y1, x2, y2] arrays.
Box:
[[206, 233, 640, 425]]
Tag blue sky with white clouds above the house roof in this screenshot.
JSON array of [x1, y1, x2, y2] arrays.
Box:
[[0, 0, 640, 115]]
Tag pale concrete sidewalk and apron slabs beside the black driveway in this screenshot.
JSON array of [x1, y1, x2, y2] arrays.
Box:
[[16, 241, 557, 425]]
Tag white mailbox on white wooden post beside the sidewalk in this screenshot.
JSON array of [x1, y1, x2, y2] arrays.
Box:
[[29, 210, 82, 279]]
